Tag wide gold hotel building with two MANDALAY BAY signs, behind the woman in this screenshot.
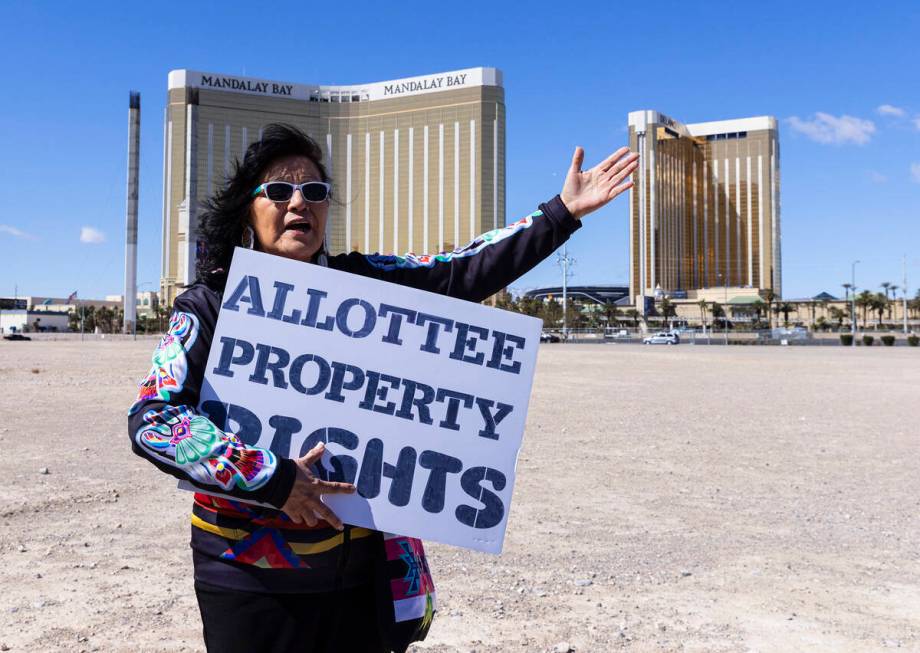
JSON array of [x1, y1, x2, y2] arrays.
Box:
[[161, 68, 505, 302]]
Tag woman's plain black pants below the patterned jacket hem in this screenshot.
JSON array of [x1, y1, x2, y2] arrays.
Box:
[[195, 582, 385, 653]]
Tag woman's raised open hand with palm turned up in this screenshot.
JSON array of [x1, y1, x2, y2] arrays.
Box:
[[560, 146, 639, 220]]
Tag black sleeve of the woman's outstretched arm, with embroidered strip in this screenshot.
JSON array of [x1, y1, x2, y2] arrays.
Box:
[[329, 195, 581, 302]]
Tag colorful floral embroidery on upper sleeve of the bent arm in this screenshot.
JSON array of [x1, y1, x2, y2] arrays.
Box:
[[129, 311, 198, 414]]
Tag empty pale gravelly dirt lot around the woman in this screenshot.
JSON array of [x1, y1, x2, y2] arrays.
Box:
[[0, 340, 920, 653]]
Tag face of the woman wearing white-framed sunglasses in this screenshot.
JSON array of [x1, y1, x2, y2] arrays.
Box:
[[250, 155, 329, 261]]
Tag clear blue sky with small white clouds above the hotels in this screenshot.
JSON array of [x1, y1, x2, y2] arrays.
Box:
[[0, 0, 920, 298]]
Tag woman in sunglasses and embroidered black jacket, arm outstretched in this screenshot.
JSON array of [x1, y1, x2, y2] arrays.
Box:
[[128, 125, 637, 653]]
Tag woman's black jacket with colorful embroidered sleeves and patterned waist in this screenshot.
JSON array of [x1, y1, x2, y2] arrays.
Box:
[[128, 196, 581, 592]]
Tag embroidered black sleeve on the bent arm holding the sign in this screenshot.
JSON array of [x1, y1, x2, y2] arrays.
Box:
[[128, 289, 294, 507]]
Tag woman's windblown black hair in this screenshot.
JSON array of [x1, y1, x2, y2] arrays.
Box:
[[196, 123, 329, 286]]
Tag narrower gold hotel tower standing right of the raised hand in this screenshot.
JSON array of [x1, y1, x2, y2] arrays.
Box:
[[629, 111, 782, 310]]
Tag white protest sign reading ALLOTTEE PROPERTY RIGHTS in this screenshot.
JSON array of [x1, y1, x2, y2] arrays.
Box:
[[191, 249, 541, 553]]
